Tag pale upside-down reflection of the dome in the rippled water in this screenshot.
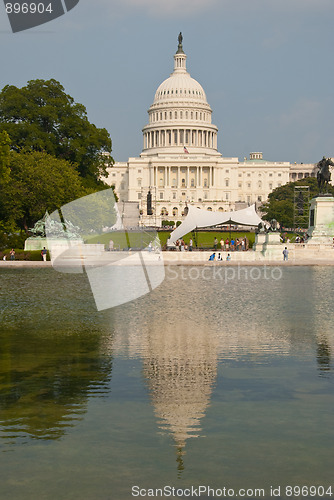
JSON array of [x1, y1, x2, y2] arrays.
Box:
[[144, 321, 218, 456]]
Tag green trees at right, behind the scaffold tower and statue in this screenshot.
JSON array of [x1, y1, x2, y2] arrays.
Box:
[[261, 177, 334, 227]]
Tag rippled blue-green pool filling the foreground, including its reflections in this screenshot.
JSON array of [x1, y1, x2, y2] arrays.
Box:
[[0, 267, 334, 500]]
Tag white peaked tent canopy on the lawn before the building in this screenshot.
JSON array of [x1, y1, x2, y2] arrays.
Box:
[[169, 205, 262, 243]]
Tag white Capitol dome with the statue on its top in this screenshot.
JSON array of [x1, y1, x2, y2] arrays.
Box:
[[141, 33, 220, 156]]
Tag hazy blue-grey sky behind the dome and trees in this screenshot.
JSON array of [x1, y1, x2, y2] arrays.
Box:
[[0, 0, 334, 163]]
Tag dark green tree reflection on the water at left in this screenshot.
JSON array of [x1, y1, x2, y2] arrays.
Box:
[[0, 330, 112, 441]]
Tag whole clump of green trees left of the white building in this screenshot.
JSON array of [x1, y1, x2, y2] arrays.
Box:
[[0, 79, 114, 248]]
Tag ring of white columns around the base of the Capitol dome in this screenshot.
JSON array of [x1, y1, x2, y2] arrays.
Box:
[[144, 128, 217, 149]]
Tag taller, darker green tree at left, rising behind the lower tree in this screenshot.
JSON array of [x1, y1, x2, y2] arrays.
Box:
[[0, 79, 114, 188]]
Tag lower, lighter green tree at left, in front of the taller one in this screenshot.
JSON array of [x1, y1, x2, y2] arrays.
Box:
[[0, 151, 92, 231]]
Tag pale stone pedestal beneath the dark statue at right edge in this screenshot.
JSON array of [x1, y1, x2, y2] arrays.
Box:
[[306, 195, 334, 245]]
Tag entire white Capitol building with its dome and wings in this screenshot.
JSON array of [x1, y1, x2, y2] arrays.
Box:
[[105, 33, 316, 226]]
